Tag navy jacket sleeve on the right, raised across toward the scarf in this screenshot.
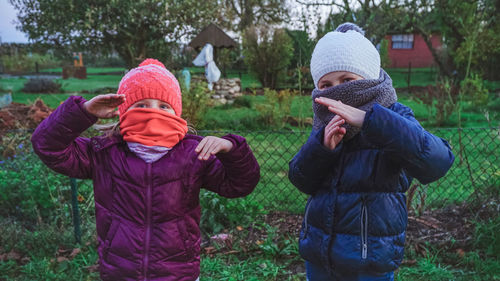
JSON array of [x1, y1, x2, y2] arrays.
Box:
[[361, 103, 455, 184]]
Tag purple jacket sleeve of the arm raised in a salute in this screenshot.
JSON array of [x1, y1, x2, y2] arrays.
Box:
[[31, 96, 97, 179]]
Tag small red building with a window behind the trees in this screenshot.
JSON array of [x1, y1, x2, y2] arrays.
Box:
[[385, 34, 442, 68]]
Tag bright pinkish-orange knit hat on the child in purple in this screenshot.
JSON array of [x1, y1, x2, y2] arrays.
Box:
[[117, 59, 182, 117]]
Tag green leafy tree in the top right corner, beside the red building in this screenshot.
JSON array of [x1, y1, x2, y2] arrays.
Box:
[[392, 0, 500, 81]]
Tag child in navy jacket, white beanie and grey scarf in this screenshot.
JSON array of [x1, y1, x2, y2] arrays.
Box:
[[289, 23, 454, 281]]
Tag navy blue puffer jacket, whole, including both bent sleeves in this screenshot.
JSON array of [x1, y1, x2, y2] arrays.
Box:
[[289, 103, 454, 273]]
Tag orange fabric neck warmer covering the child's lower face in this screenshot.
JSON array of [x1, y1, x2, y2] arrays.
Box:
[[120, 108, 188, 148]]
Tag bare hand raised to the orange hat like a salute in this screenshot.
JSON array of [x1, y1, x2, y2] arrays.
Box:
[[83, 94, 125, 118]]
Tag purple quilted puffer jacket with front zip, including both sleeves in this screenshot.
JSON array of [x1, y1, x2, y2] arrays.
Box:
[[31, 97, 260, 280]]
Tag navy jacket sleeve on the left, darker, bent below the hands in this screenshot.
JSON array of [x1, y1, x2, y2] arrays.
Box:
[[288, 127, 342, 195]]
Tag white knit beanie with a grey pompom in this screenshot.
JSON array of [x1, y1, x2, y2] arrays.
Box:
[[311, 22, 380, 88]]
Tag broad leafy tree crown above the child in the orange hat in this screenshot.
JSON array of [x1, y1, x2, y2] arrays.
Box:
[[9, 0, 217, 68]]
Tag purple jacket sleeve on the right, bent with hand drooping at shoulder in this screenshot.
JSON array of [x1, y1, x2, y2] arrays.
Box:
[[203, 134, 260, 198]]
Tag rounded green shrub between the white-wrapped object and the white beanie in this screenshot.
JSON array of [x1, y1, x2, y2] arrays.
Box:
[[243, 26, 293, 89]]
